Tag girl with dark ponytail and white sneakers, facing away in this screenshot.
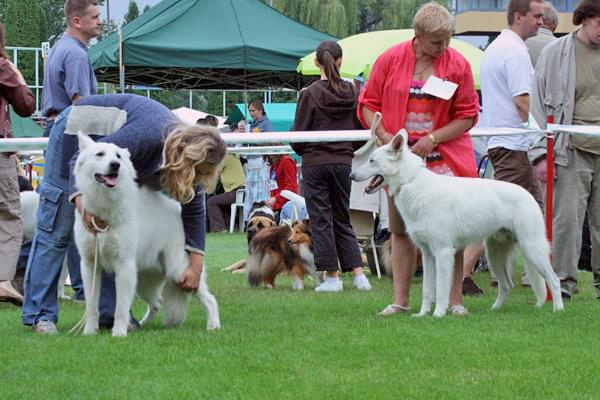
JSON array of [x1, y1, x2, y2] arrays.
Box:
[[292, 40, 371, 292]]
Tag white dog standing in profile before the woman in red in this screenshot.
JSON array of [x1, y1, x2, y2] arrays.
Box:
[[351, 130, 563, 317]]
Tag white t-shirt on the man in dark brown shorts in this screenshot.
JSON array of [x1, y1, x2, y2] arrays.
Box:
[[480, 29, 534, 151]]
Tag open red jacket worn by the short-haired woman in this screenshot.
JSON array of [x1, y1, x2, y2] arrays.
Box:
[[357, 40, 479, 177]]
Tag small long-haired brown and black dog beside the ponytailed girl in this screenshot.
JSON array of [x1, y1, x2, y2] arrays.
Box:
[[246, 219, 316, 290]]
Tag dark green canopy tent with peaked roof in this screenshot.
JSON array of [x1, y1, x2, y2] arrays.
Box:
[[89, 0, 335, 90]]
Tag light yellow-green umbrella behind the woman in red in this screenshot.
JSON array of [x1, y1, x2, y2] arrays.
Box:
[[298, 29, 483, 89]]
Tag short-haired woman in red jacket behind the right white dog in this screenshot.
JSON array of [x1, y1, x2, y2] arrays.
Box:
[[358, 3, 479, 316]]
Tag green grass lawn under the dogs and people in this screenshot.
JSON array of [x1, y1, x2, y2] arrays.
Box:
[[0, 234, 600, 399]]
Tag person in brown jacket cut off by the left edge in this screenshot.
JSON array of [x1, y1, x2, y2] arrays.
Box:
[[0, 23, 35, 305]]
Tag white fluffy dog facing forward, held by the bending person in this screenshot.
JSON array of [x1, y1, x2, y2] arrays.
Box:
[[75, 134, 220, 336]]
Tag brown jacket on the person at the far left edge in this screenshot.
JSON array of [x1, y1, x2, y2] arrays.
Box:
[[0, 57, 35, 139]]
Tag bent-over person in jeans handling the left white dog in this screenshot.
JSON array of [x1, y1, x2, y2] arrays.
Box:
[[22, 94, 227, 333]]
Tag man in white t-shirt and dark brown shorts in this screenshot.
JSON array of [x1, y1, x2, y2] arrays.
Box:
[[480, 0, 544, 207]]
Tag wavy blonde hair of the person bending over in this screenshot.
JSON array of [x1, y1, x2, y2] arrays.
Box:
[[161, 124, 227, 204]]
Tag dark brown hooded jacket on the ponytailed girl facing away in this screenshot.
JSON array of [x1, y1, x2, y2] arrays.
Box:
[[292, 80, 363, 166]]
